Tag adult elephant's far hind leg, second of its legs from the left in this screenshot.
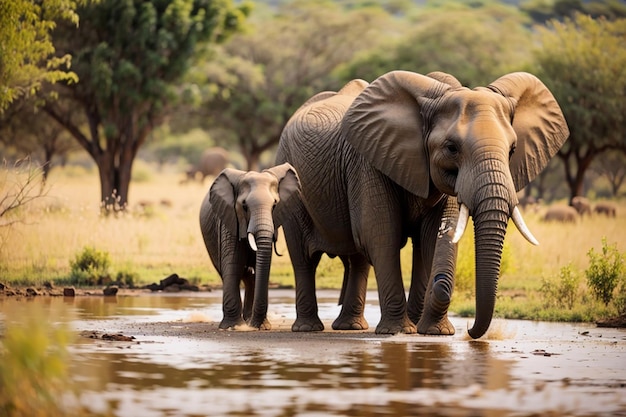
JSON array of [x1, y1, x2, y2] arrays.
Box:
[[332, 254, 370, 330]]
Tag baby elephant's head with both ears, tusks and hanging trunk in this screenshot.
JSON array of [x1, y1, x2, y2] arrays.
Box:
[[209, 163, 300, 327]]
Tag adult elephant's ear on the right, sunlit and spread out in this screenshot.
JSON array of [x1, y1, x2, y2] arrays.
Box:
[[487, 72, 569, 191]]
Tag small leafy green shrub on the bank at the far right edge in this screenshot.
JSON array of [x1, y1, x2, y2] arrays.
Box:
[[585, 238, 624, 305]]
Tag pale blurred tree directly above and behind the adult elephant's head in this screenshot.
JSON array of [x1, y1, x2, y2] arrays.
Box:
[[344, 1, 532, 87]]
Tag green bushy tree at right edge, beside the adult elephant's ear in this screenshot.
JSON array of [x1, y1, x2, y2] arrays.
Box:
[[536, 15, 626, 199]]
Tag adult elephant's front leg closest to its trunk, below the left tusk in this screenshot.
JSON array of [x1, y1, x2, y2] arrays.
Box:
[[417, 198, 458, 335]]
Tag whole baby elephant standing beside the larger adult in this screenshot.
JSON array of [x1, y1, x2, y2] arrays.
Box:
[[200, 163, 300, 330]]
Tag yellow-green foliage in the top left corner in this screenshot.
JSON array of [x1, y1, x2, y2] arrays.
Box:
[[0, 0, 78, 115]]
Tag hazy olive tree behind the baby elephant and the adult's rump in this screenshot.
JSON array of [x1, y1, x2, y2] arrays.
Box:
[[182, 1, 389, 169]]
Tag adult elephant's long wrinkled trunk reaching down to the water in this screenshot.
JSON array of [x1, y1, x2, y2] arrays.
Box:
[[468, 159, 517, 339]]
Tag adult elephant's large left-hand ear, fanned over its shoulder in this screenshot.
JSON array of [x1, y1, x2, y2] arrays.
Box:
[[342, 71, 451, 198]]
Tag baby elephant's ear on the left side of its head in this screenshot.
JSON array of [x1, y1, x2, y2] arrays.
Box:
[[209, 168, 248, 239]]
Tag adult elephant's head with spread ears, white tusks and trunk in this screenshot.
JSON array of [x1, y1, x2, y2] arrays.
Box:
[[342, 71, 569, 338]]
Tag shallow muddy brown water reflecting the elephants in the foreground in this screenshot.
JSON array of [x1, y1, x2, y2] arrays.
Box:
[[0, 290, 626, 417]]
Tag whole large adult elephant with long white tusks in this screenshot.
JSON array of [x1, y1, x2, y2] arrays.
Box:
[[276, 71, 569, 338]]
